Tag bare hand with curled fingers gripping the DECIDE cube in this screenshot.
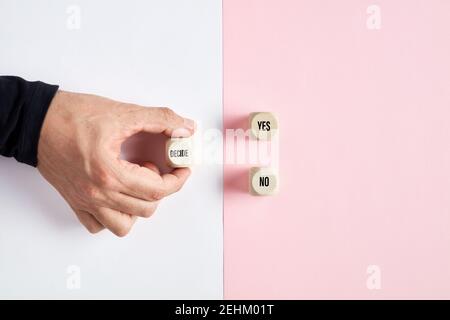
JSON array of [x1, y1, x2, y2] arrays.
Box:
[[38, 91, 195, 237]]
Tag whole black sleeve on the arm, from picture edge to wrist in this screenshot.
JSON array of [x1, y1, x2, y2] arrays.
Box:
[[0, 76, 58, 167]]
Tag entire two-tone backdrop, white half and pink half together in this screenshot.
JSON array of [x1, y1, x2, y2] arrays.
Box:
[[0, 0, 450, 299]]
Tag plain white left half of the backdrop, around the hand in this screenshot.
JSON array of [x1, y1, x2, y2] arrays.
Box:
[[0, 0, 223, 299]]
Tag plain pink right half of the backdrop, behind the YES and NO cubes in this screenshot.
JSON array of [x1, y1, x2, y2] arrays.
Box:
[[224, 0, 450, 299]]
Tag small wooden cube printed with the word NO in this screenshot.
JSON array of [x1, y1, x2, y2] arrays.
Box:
[[249, 167, 279, 196]]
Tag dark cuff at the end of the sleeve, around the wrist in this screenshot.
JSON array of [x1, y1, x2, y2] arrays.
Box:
[[16, 81, 59, 167]]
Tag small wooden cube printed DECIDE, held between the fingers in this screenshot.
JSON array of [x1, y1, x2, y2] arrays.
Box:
[[166, 138, 194, 168]]
